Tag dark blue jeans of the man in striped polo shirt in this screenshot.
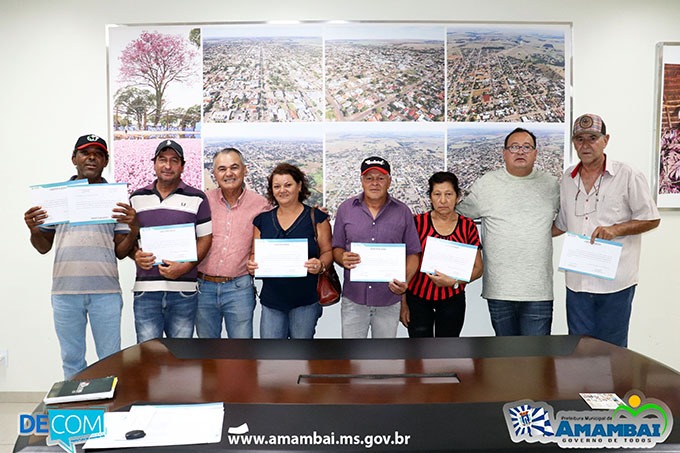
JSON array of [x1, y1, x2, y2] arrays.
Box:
[[133, 291, 198, 343]]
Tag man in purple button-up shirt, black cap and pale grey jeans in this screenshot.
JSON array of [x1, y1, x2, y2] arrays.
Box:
[[333, 156, 421, 338]]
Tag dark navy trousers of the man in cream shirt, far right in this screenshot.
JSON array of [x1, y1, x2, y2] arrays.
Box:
[[567, 285, 637, 347]]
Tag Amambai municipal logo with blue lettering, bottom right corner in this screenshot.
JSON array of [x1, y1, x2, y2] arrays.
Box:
[[503, 390, 673, 448]]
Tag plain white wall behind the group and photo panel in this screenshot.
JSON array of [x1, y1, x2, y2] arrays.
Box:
[[0, 0, 680, 391]]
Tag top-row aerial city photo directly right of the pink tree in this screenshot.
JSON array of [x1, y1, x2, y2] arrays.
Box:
[[203, 26, 323, 123]]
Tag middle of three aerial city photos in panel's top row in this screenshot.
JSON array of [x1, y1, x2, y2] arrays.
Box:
[[325, 26, 444, 121]]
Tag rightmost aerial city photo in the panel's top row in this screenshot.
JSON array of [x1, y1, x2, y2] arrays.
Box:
[[446, 26, 565, 123]]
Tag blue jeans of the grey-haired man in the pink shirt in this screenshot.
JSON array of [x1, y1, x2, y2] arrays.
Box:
[[196, 275, 255, 338]]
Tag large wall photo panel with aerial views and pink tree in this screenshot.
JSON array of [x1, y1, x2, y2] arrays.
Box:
[[108, 22, 571, 212]]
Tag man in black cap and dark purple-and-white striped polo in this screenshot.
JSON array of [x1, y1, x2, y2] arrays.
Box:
[[130, 140, 212, 343]]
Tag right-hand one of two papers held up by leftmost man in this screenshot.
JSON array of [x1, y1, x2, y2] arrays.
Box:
[[67, 182, 128, 225]]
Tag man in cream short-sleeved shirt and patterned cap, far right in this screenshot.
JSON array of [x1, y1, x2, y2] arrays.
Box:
[[553, 113, 661, 346]]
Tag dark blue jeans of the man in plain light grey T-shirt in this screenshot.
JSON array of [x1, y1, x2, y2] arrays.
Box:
[[487, 299, 553, 336]]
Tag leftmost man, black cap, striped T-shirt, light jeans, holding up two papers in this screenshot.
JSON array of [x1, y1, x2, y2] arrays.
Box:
[[24, 134, 139, 379]]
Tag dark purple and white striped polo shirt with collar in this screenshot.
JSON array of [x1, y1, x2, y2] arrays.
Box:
[[130, 181, 212, 292]]
